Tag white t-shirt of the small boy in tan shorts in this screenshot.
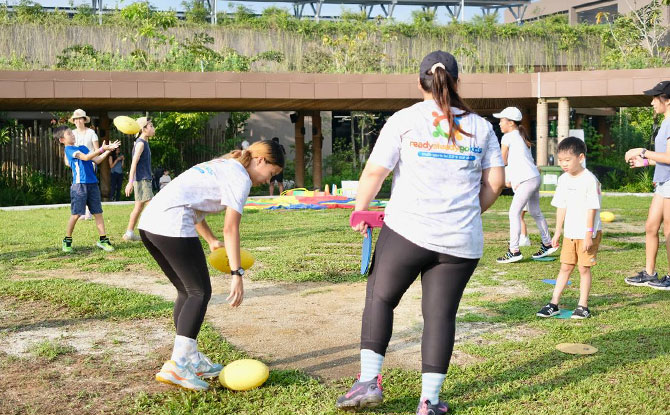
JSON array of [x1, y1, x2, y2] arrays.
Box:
[[551, 169, 602, 239]]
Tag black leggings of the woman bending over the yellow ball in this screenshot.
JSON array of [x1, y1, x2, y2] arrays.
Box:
[[140, 229, 212, 339]]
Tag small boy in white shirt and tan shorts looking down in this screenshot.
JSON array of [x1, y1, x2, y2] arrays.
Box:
[[537, 137, 602, 318]]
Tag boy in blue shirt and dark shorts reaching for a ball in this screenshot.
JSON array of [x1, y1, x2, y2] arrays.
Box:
[[54, 126, 121, 252]]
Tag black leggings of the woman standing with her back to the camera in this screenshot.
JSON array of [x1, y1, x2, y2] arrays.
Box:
[[361, 226, 479, 373]]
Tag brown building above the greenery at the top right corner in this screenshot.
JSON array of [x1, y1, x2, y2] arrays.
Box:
[[505, 0, 670, 25]]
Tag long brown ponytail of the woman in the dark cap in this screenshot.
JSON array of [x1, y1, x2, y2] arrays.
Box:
[[419, 66, 473, 144]]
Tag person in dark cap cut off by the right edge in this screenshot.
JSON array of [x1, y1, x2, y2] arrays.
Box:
[[626, 81, 670, 290]]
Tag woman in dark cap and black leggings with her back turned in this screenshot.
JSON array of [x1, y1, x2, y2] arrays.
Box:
[[336, 51, 504, 414]]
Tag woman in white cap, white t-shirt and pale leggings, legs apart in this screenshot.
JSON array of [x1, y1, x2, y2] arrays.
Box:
[[493, 107, 557, 264]]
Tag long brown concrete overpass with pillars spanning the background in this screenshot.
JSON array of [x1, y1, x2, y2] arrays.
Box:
[[0, 68, 670, 187]]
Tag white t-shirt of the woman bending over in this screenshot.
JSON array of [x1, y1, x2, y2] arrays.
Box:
[[138, 159, 251, 237]]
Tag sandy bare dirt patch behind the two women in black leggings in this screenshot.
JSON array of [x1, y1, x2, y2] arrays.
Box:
[[7, 273, 540, 380]]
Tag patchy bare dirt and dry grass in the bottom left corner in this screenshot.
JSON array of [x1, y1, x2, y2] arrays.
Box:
[[0, 297, 172, 415]]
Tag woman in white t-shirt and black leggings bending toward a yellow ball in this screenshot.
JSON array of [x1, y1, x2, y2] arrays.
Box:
[[139, 140, 284, 390]]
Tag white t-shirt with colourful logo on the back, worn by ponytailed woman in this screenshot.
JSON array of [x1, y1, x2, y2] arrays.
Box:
[[368, 100, 503, 258]]
